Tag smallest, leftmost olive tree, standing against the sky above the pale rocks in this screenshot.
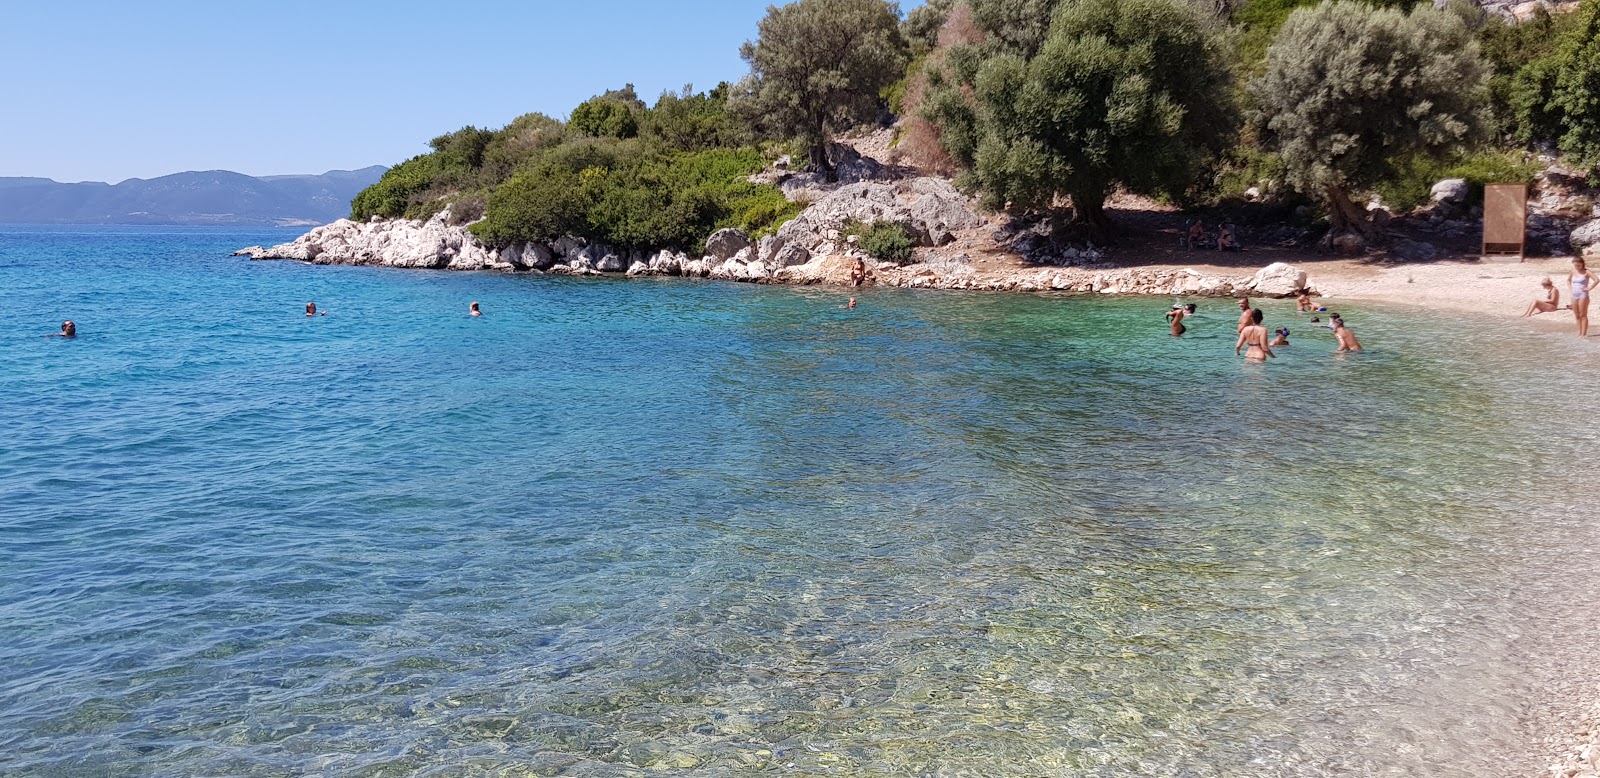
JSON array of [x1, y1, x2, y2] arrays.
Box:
[[738, 0, 906, 179]]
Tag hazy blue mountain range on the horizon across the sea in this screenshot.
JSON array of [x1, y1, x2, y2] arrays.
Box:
[[0, 165, 389, 227]]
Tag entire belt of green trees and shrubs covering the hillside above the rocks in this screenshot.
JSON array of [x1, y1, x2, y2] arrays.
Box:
[[352, 0, 1600, 258]]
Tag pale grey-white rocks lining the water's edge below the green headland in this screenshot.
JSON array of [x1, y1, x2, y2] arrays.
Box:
[[234, 178, 1307, 296]]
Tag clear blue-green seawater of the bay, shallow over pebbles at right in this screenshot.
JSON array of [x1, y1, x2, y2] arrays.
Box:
[[0, 227, 1600, 776]]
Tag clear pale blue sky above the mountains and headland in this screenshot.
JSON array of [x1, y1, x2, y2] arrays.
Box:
[[0, 0, 920, 182]]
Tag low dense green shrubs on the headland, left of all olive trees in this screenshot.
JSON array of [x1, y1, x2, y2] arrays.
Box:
[[350, 85, 798, 248]]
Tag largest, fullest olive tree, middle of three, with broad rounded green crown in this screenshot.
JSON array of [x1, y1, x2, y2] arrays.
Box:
[[925, 0, 1235, 239]]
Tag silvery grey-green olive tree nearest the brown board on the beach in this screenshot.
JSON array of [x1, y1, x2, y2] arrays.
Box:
[[1250, 0, 1490, 243]]
